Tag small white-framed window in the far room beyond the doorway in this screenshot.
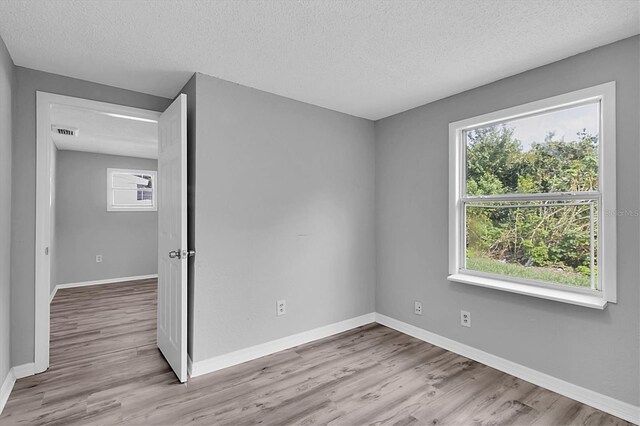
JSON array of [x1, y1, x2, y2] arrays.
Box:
[[107, 168, 158, 212]]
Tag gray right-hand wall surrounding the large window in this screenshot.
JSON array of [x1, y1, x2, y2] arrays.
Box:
[[376, 37, 640, 405]]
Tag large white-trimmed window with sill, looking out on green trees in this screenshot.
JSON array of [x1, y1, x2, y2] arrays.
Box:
[[448, 82, 617, 309]]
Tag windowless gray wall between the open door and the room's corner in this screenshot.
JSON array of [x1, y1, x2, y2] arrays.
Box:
[[192, 74, 375, 361]]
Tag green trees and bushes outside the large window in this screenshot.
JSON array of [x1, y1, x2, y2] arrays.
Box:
[[466, 126, 598, 285]]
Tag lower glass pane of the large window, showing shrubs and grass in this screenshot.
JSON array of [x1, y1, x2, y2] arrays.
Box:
[[465, 200, 597, 288]]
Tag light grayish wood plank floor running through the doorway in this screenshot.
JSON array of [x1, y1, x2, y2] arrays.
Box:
[[0, 280, 627, 426]]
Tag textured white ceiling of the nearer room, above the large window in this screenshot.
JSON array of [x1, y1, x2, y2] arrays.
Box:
[[0, 0, 640, 119]]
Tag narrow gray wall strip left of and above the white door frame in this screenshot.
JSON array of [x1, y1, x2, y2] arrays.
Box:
[[11, 67, 171, 365]]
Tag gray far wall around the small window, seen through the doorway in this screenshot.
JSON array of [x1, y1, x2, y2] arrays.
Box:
[[52, 151, 158, 289]]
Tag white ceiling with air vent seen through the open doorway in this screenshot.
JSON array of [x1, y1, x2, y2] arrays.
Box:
[[51, 105, 158, 158]]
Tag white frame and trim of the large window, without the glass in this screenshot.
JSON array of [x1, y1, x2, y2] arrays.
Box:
[[447, 82, 617, 309]]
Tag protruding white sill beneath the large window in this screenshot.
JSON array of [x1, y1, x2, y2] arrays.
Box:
[[447, 273, 607, 310]]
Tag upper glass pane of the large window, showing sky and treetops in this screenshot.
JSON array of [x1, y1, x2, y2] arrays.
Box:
[[464, 102, 600, 195]]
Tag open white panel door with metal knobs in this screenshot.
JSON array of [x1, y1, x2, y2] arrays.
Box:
[[157, 94, 189, 382]]
